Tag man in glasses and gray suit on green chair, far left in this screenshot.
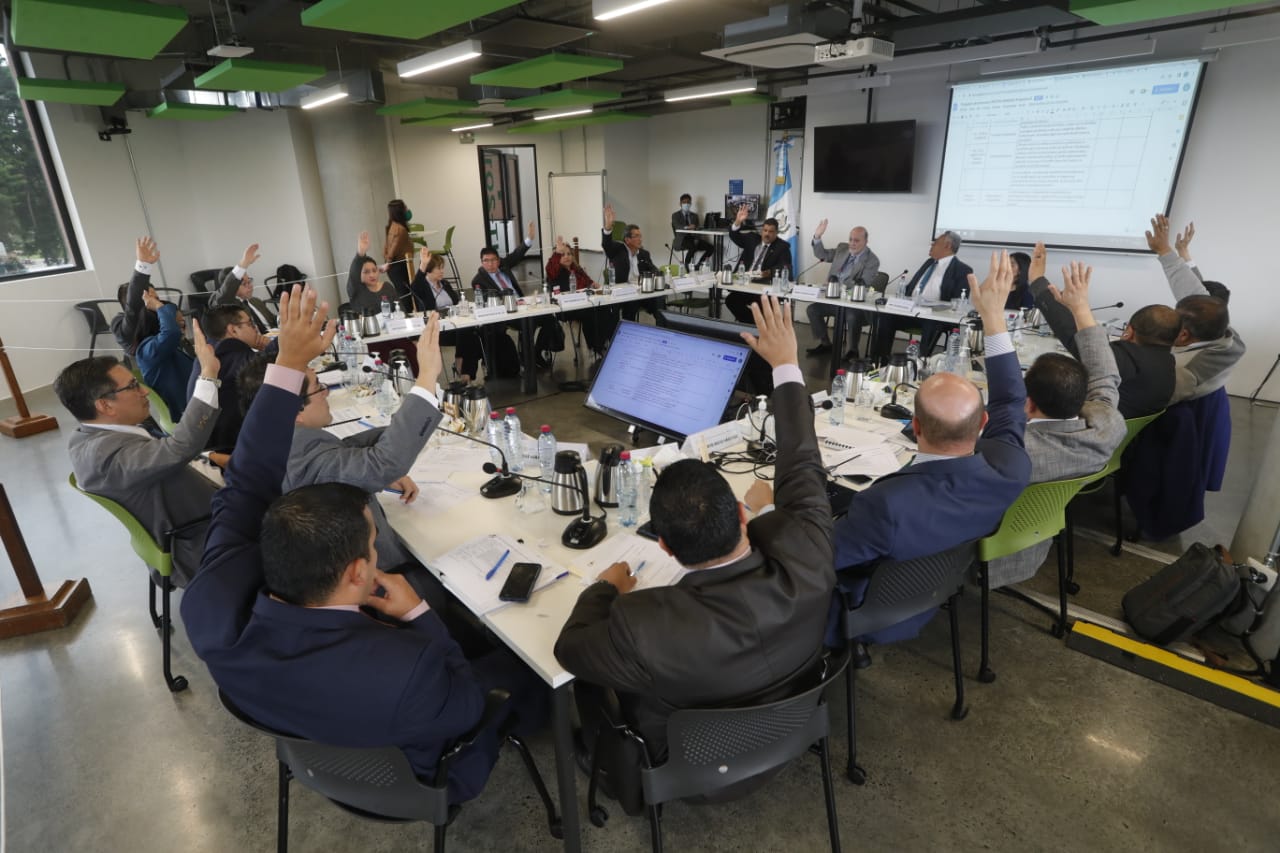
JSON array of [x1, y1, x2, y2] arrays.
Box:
[[54, 323, 219, 587]]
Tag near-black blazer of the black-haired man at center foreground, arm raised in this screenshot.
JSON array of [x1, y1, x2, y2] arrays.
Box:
[[556, 379, 834, 754]]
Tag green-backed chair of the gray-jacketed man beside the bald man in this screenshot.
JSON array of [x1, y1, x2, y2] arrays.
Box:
[[978, 474, 1097, 684]]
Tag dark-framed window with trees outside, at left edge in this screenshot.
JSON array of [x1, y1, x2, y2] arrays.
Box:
[[0, 45, 83, 282]]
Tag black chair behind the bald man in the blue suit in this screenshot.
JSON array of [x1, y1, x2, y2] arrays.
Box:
[[840, 542, 974, 785]]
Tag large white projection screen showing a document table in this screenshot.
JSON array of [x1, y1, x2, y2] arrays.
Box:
[[934, 59, 1203, 251]]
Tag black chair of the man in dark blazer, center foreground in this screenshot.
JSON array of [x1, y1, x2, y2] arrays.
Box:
[[586, 652, 849, 853]]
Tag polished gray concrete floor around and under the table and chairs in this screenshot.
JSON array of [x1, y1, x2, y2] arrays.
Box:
[[0, 324, 1280, 853]]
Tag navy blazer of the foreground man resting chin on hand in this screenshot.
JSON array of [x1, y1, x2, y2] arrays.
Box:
[[182, 371, 497, 802]]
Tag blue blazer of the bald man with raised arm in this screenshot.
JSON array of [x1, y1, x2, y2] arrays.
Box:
[[827, 343, 1032, 646]]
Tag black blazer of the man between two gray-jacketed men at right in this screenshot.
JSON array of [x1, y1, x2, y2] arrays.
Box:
[[1030, 278, 1178, 420]]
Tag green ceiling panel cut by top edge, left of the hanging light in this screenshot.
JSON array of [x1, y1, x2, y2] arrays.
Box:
[[302, 0, 521, 41]]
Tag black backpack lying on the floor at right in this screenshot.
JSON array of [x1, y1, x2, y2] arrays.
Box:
[[1121, 542, 1240, 646]]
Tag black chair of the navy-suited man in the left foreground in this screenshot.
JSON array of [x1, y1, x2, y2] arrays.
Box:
[[218, 689, 563, 853]]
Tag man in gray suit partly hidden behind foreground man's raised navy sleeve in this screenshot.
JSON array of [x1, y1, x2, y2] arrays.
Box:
[[239, 326, 442, 571]]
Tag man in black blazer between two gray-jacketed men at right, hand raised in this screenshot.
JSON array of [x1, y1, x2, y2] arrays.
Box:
[[1029, 243, 1183, 419]]
